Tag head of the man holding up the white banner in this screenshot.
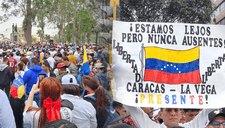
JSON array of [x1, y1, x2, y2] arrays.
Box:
[[159, 108, 181, 127]]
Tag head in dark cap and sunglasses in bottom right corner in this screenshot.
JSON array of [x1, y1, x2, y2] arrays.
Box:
[[207, 109, 225, 128]]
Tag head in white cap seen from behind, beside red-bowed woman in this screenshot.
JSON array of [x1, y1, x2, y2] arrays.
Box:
[[61, 74, 80, 96]]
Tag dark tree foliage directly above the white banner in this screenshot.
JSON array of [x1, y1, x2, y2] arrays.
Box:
[[120, 0, 213, 24]]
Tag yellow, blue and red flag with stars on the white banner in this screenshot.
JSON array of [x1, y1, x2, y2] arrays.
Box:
[[144, 47, 201, 84]]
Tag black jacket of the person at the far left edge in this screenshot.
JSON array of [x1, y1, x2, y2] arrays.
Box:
[[0, 64, 14, 87]]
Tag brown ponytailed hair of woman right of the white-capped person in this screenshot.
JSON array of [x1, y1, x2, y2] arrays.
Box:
[[81, 75, 109, 113]]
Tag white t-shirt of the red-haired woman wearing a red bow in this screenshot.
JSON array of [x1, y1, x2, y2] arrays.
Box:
[[23, 107, 72, 128]]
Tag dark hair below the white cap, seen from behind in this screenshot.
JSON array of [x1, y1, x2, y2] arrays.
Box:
[[62, 85, 80, 96]]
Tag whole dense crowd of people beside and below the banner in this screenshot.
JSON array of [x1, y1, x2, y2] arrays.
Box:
[[0, 42, 225, 128]]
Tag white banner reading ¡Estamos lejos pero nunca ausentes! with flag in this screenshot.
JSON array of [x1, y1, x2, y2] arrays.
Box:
[[112, 21, 225, 108]]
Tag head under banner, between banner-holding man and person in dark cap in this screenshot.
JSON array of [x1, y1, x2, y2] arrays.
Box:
[[183, 109, 200, 122]]
